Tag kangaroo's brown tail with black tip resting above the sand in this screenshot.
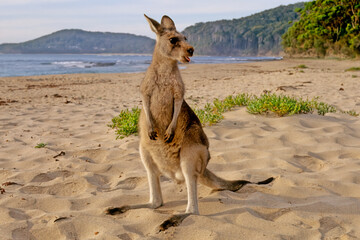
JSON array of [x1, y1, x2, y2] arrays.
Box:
[[199, 169, 274, 192]]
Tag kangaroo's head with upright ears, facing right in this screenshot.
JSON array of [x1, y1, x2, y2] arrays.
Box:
[[144, 14, 194, 63]]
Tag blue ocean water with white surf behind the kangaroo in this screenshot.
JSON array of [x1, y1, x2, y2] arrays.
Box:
[[0, 54, 281, 77]]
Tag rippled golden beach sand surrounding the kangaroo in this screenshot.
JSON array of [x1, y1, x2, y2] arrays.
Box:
[[0, 59, 360, 240]]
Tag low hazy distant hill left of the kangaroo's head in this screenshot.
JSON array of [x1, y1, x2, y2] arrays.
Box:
[[0, 29, 155, 53]]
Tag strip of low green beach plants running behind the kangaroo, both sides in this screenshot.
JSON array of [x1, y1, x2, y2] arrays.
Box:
[[108, 93, 350, 139]]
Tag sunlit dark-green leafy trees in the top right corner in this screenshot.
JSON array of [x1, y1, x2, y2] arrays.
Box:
[[282, 0, 360, 57]]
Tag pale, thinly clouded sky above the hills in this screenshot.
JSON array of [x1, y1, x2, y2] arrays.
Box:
[[0, 0, 306, 44]]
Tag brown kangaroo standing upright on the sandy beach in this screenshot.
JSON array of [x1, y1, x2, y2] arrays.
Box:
[[107, 15, 274, 227]]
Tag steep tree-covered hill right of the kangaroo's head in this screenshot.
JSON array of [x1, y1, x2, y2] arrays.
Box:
[[183, 2, 304, 56]]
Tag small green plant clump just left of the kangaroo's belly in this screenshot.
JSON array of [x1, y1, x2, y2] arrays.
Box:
[[108, 107, 140, 139]]
